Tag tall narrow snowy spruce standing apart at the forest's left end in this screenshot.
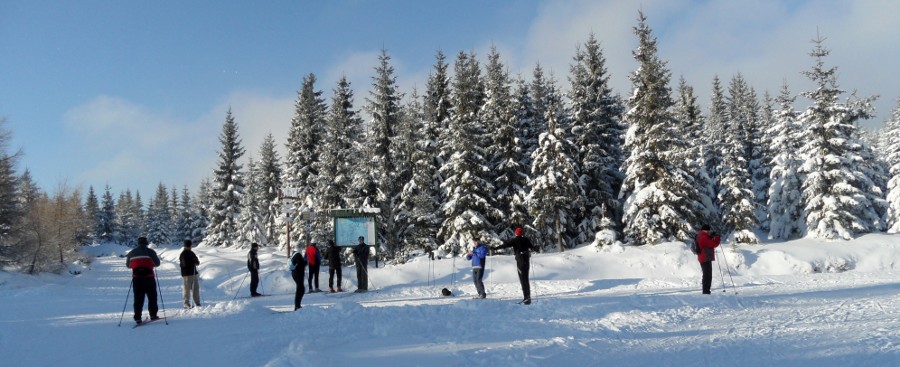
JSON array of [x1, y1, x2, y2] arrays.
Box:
[[203, 109, 244, 247]]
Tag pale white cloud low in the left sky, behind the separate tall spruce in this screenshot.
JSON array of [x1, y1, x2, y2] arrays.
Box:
[[60, 92, 293, 200]]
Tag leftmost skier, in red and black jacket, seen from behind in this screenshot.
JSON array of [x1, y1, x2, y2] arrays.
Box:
[[125, 237, 159, 324]]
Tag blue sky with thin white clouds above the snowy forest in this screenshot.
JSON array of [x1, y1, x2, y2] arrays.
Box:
[[0, 0, 900, 198]]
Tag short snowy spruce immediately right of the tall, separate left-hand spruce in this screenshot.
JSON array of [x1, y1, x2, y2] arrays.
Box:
[[235, 157, 269, 248]]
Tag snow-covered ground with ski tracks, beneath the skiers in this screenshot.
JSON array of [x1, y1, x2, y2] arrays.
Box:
[[0, 235, 900, 367]]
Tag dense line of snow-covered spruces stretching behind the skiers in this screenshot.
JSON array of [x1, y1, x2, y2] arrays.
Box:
[[4, 14, 900, 274]]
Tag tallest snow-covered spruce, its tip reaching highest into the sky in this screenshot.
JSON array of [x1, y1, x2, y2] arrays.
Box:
[[620, 12, 704, 245]]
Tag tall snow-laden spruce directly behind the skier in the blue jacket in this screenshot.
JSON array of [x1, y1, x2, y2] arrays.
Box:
[[438, 52, 500, 254]]
